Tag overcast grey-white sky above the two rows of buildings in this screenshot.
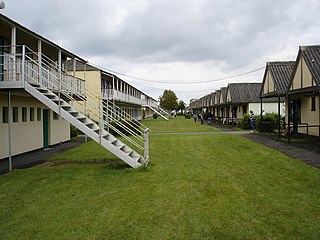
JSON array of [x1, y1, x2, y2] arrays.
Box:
[[0, 0, 320, 103]]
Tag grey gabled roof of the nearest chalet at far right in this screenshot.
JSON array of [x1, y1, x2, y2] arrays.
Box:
[[288, 45, 320, 90]]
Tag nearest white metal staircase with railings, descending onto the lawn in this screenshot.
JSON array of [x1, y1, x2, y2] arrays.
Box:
[[0, 46, 149, 168]]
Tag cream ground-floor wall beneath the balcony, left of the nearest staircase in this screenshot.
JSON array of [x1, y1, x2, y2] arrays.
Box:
[[0, 93, 70, 159]]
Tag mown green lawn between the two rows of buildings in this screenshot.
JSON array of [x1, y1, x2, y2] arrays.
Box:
[[0, 118, 320, 240]]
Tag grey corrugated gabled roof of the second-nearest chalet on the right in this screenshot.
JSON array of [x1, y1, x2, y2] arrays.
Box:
[[260, 61, 295, 96]]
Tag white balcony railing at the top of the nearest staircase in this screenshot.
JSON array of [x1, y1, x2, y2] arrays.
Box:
[[0, 45, 85, 96]]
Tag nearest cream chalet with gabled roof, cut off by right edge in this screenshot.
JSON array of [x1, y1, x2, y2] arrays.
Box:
[[286, 45, 320, 136]]
